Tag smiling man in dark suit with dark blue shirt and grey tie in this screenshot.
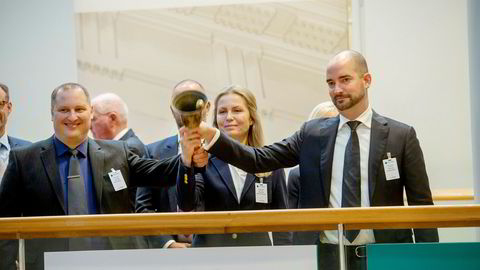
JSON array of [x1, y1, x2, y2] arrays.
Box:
[[0, 83, 204, 270]]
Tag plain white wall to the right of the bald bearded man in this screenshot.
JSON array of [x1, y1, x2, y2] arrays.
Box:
[[354, 0, 473, 189]]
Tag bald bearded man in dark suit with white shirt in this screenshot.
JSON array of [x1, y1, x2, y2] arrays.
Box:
[[188, 50, 438, 269]]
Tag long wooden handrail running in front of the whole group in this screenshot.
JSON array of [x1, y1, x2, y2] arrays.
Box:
[[0, 205, 480, 239]]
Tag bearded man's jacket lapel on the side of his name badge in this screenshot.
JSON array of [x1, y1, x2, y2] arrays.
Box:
[[368, 111, 390, 202]]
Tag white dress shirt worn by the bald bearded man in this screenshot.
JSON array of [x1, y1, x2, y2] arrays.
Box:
[[320, 106, 375, 245]]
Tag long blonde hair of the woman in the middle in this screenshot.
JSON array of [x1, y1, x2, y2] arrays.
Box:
[[213, 85, 264, 147]]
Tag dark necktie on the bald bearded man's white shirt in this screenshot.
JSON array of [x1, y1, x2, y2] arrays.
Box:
[[342, 121, 361, 243]]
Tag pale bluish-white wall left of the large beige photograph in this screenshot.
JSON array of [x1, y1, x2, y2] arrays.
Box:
[[0, 0, 77, 141]]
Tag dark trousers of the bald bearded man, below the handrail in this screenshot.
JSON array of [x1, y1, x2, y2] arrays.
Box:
[[317, 243, 367, 270]]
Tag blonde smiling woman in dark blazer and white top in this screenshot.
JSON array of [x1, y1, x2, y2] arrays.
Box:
[[177, 86, 291, 247]]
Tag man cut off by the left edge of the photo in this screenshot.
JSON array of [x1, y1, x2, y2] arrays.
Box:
[[0, 83, 32, 270]]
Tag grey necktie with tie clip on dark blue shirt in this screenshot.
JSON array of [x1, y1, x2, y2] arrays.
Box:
[[67, 149, 88, 215]]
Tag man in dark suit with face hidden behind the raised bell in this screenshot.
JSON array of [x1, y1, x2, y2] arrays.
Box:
[[135, 79, 210, 248]]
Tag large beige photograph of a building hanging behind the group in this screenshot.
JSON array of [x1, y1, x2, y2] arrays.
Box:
[[76, 0, 350, 143]]
